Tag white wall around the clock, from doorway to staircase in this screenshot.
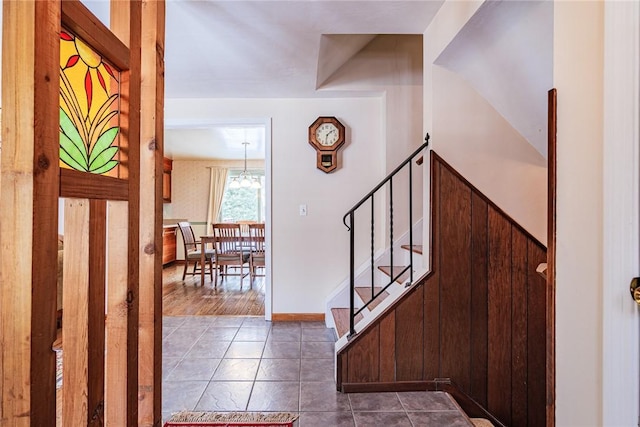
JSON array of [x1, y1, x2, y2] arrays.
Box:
[[165, 35, 422, 313]]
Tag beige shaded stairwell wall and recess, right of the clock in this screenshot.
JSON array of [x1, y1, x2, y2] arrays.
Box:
[[322, 34, 425, 241]]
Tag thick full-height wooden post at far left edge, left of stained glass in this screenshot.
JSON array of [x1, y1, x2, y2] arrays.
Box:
[[0, 1, 60, 426]]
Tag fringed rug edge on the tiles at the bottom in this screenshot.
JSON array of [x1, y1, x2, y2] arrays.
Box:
[[164, 411, 298, 427]]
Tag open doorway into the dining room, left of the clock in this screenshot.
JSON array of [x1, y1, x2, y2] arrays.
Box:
[[163, 118, 271, 320]]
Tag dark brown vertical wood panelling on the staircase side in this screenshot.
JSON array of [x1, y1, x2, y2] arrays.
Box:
[[338, 152, 547, 427]]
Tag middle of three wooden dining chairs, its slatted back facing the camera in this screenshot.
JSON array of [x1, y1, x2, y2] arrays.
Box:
[[213, 223, 249, 289]]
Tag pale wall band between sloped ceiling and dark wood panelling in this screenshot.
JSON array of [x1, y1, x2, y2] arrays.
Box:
[[432, 66, 547, 244]]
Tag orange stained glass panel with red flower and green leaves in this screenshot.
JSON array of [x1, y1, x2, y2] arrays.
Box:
[[60, 30, 120, 177]]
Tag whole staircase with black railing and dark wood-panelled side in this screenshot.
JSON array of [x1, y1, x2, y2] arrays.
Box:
[[327, 146, 553, 427]]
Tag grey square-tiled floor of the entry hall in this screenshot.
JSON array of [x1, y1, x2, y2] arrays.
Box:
[[162, 316, 471, 427]]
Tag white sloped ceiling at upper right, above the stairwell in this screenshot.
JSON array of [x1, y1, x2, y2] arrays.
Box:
[[436, 1, 553, 157]]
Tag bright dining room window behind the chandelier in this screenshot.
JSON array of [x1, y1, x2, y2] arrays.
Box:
[[220, 170, 265, 222]]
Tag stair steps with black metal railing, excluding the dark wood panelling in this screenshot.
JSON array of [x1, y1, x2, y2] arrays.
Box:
[[326, 139, 429, 351]]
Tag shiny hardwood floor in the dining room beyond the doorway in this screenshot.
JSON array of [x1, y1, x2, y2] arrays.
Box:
[[162, 263, 264, 316]]
